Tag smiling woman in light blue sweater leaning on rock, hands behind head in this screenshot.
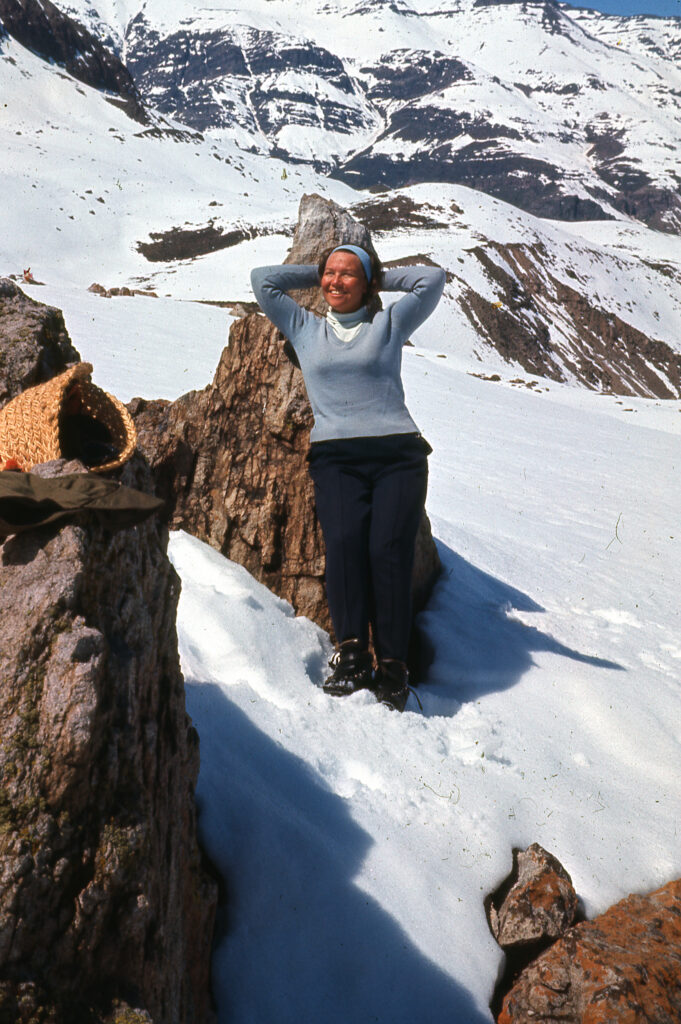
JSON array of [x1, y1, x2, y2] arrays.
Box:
[[251, 244, 444, 711]]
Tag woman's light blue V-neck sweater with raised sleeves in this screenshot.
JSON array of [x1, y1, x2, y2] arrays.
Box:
[[251, 264, 444, 441]]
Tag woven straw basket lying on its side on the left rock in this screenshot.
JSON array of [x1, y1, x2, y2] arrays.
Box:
[[0, 362, 137, 473]]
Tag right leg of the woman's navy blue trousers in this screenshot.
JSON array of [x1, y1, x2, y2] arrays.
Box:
[[369, 455, 428, 662]]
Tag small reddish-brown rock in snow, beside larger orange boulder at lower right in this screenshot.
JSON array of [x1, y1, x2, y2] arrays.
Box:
[[490, 843, 578, 949]]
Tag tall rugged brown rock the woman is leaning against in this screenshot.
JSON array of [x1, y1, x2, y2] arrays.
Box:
[[129, 197, 439, 647]]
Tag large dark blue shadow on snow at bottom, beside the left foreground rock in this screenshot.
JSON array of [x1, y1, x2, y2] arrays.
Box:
[[186, 681, 494, 1024]]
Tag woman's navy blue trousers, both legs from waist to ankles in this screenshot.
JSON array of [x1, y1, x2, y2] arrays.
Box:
[[308, 434, 432, 662]]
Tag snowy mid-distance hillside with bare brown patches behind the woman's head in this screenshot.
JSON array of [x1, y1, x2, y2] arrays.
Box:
[[5, 18, 681, 397]]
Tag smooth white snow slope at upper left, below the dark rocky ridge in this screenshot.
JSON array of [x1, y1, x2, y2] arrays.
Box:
[[0, 29, 355, 288]]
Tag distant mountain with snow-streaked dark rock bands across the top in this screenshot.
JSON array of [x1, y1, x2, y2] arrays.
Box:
[[57, 0, 681, 231]]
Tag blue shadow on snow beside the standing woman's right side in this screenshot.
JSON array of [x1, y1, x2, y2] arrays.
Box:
[[416, 541, 625, 717]]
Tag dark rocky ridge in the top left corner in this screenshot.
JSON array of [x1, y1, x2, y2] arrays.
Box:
[[0, 0, 148, 123]]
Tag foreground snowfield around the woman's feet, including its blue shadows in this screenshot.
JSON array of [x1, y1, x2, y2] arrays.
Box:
[[171, 353, 681, 1024]]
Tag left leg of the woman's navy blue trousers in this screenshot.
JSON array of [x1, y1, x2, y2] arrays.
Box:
[[310, 460, 371, 648]]
